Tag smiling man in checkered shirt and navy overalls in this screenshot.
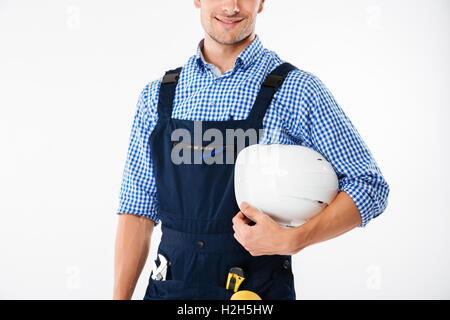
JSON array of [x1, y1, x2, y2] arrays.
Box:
[[114, 0, 389, 299]]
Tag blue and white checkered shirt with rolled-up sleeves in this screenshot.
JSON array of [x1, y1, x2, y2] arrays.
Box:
[[117, 35, 389, 227]]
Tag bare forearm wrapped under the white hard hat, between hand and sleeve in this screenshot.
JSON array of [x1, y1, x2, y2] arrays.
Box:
[[291, 191, 362, 253]]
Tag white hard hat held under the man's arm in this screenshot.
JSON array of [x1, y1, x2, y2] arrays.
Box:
[[234, 144, 338, 226]]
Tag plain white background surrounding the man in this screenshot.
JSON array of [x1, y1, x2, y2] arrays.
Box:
[[0, 0, 450, 299]]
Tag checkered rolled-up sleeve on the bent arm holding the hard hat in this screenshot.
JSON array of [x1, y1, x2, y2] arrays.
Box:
[[301, 75, 389, 227]]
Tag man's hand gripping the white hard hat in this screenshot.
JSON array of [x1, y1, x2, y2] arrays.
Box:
[[233, 202, 295, 256]]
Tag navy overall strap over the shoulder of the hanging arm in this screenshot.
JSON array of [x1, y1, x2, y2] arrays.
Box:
[[158, 67, 182, 118]]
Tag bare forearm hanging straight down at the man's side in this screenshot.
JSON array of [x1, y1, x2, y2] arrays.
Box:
[[113, 214, 154, 299]]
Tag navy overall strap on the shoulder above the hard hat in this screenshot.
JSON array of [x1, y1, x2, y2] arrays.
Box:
[[248, 62, 297, 121]]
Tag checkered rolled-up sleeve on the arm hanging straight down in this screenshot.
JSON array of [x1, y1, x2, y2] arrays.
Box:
[[116, 79, 161, 224]]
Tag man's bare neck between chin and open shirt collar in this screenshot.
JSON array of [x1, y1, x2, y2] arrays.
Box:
[[202, 33, 256, 74]]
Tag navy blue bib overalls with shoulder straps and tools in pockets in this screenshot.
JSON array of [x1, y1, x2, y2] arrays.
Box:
[[144, 63, 295, 300]]
